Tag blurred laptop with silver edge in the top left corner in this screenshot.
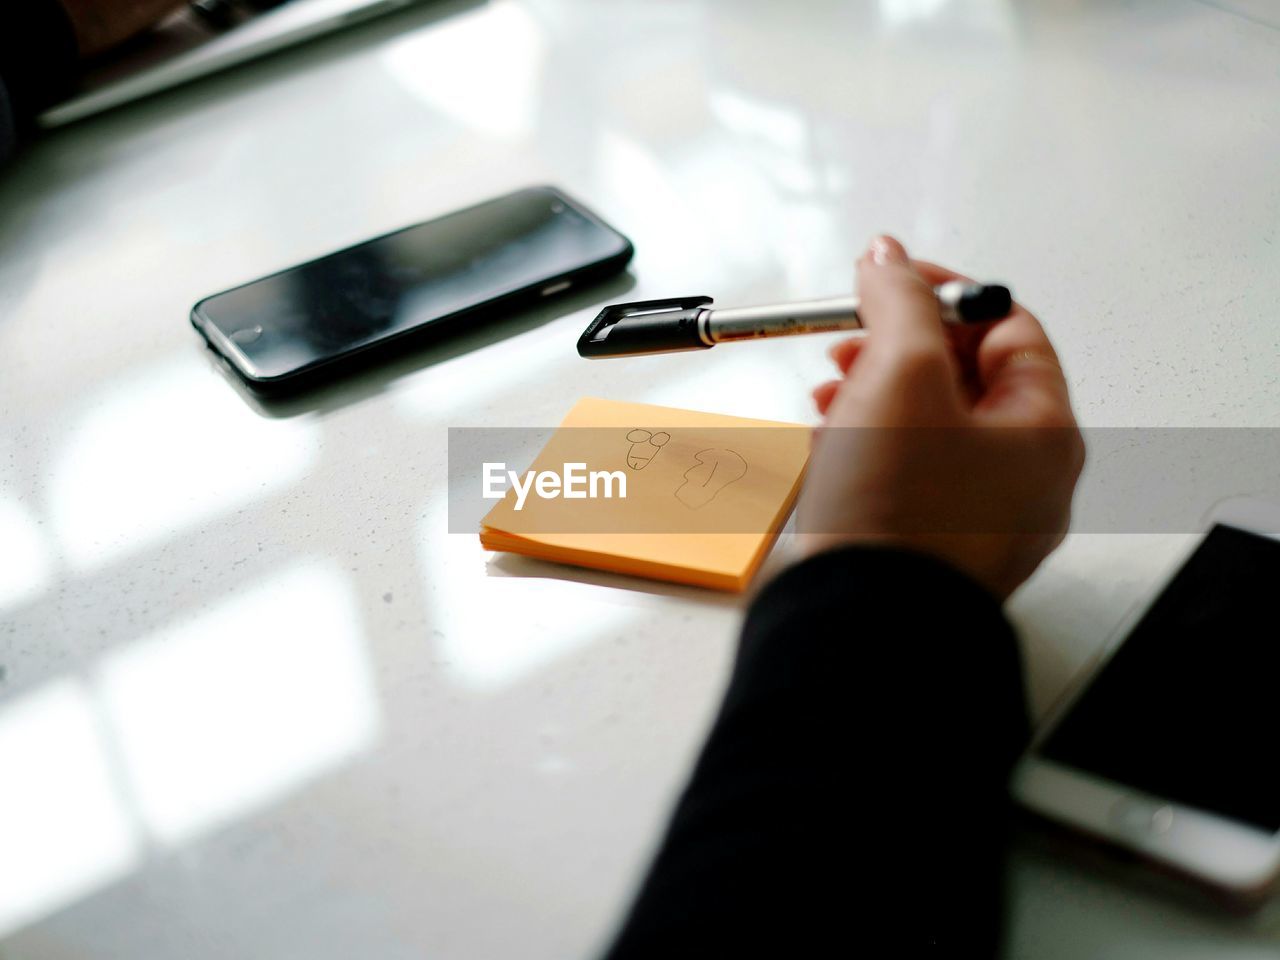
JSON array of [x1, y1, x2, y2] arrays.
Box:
[[40, 0, 422, 127]]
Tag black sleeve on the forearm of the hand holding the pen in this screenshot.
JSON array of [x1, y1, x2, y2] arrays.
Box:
[[607, 547, 1028, 960]]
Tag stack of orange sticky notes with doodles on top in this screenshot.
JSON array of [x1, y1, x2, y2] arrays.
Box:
[[480, 398, 810, 590]]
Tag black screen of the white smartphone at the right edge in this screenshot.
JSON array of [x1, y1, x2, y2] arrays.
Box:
[[1039, 525, 1280, 833]]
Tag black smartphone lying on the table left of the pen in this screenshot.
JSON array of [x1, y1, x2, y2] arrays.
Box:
[[191, 187, 632, 393]]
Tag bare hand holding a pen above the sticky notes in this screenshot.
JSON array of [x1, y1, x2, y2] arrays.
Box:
[[797, 237, 1084, 599]]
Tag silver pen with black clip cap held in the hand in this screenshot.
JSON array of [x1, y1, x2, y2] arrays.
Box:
[[577, 280, 1012, 358]]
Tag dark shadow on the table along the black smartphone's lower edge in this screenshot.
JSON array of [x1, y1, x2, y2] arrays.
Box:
[[216, 273, 645, 419]]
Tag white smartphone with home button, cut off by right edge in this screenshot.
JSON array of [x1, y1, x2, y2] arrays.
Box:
[[1012, 499, 1280, 897]]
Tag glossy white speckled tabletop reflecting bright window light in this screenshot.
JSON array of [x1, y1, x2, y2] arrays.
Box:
[[0, 0, 1280, 960]]
